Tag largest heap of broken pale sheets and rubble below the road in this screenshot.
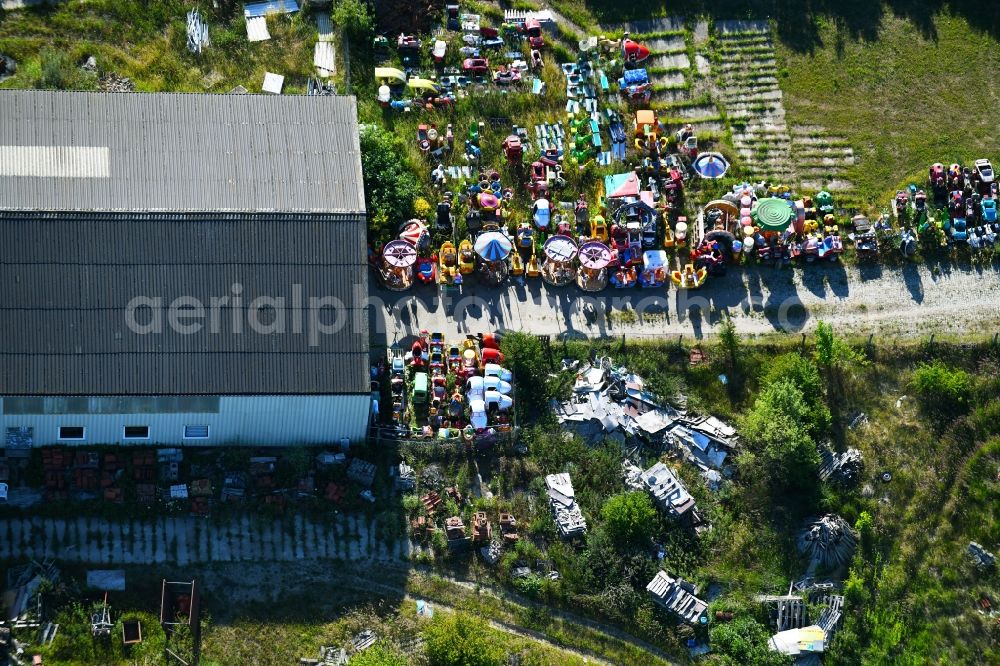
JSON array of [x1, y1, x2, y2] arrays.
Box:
[[553, 357, 738, 479]]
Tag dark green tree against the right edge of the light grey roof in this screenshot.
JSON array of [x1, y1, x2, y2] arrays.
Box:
[[361, 125, 420, 244]]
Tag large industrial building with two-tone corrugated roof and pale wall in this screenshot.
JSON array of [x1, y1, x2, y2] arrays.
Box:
[[0, 91, 371, 447]]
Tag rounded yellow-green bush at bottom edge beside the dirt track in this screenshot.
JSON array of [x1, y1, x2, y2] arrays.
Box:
[[424, 611, 507, 666]]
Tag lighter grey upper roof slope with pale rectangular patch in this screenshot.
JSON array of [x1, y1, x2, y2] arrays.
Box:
[[0, 90, 365, 213]]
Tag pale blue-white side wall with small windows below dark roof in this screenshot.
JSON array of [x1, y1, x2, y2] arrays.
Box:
[[0, 394, 371, 447]]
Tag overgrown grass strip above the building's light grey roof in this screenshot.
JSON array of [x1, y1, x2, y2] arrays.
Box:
[[0, 0, 316, 93]]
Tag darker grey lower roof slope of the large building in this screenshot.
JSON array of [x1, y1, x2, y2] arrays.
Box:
[[0, 212, 369, 395]]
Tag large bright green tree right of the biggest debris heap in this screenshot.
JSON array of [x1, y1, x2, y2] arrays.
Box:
[[742, 379, 830, 488]]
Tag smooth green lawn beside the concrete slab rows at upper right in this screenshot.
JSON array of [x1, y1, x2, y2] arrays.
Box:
[[776, 12, 1000, 203]]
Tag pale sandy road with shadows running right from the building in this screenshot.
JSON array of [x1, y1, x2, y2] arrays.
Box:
[[369, 264, 1000, 344]]
